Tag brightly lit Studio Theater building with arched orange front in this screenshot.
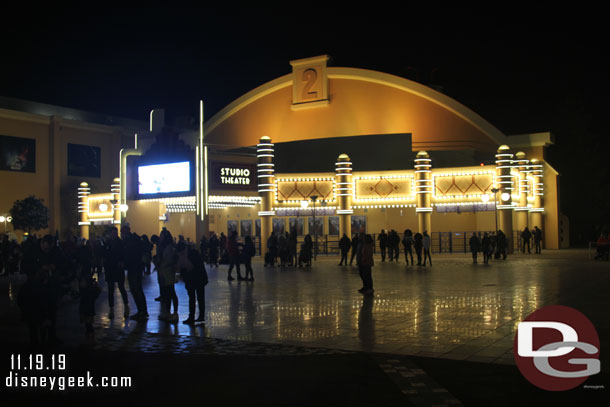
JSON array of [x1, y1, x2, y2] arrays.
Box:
[[0, 56, 567, 251]]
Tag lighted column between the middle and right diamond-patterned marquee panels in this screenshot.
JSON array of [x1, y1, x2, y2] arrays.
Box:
[[414, 151, 432, 234]]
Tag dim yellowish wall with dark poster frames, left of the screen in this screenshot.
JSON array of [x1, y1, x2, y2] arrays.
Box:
[[0, 109, 130, 242]]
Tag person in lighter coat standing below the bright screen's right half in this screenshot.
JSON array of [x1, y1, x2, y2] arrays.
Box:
[[155, 229, 178, 323]]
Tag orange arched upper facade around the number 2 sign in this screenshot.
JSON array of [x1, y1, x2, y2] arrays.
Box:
[[205, 67, 507, 151]]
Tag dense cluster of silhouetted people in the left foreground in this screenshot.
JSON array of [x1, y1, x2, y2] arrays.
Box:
[[0, 224, 211, 347]]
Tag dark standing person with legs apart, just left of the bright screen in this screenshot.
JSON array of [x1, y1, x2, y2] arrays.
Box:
[[104, 226, 129, 319]]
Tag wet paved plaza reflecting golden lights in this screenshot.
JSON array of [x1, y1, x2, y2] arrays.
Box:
[[0, 250, 610, 404]]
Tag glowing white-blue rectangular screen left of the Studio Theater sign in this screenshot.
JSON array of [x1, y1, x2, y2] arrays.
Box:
[[138, 161, 191, 195]]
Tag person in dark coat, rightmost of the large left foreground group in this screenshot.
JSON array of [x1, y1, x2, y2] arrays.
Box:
[[176, 242, 207, 325]]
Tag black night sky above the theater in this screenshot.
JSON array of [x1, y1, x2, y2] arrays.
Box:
[[0, 6, 610, 240]]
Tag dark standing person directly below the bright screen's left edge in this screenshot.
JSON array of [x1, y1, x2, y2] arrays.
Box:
[[121, 223, 148, 319]]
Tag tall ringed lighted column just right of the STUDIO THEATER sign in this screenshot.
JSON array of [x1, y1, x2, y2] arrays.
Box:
[[256, 136, 275, 256]]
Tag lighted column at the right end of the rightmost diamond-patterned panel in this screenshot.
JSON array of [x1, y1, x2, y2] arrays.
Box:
[[496, 145, 515, 253]]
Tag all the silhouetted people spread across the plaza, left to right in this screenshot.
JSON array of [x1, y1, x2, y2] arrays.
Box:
[[0, 224, 548, 350]]
